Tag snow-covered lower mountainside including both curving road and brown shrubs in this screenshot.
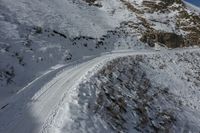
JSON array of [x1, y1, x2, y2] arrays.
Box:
[[0, 49, 200, 133]]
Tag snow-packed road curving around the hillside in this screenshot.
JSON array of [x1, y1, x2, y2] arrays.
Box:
[[0, 51, 155, 133]]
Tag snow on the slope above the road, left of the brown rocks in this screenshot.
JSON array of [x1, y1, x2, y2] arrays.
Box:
[[0, 0, 146, 101]]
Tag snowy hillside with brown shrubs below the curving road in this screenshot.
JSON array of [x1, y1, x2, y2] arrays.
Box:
[[64, 50, 200, 133]]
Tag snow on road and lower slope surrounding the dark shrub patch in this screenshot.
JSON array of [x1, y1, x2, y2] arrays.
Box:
[[0, 48, 200, 133]]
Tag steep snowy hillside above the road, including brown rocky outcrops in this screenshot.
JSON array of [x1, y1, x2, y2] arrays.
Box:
[[0, 0, 200, 106]]
